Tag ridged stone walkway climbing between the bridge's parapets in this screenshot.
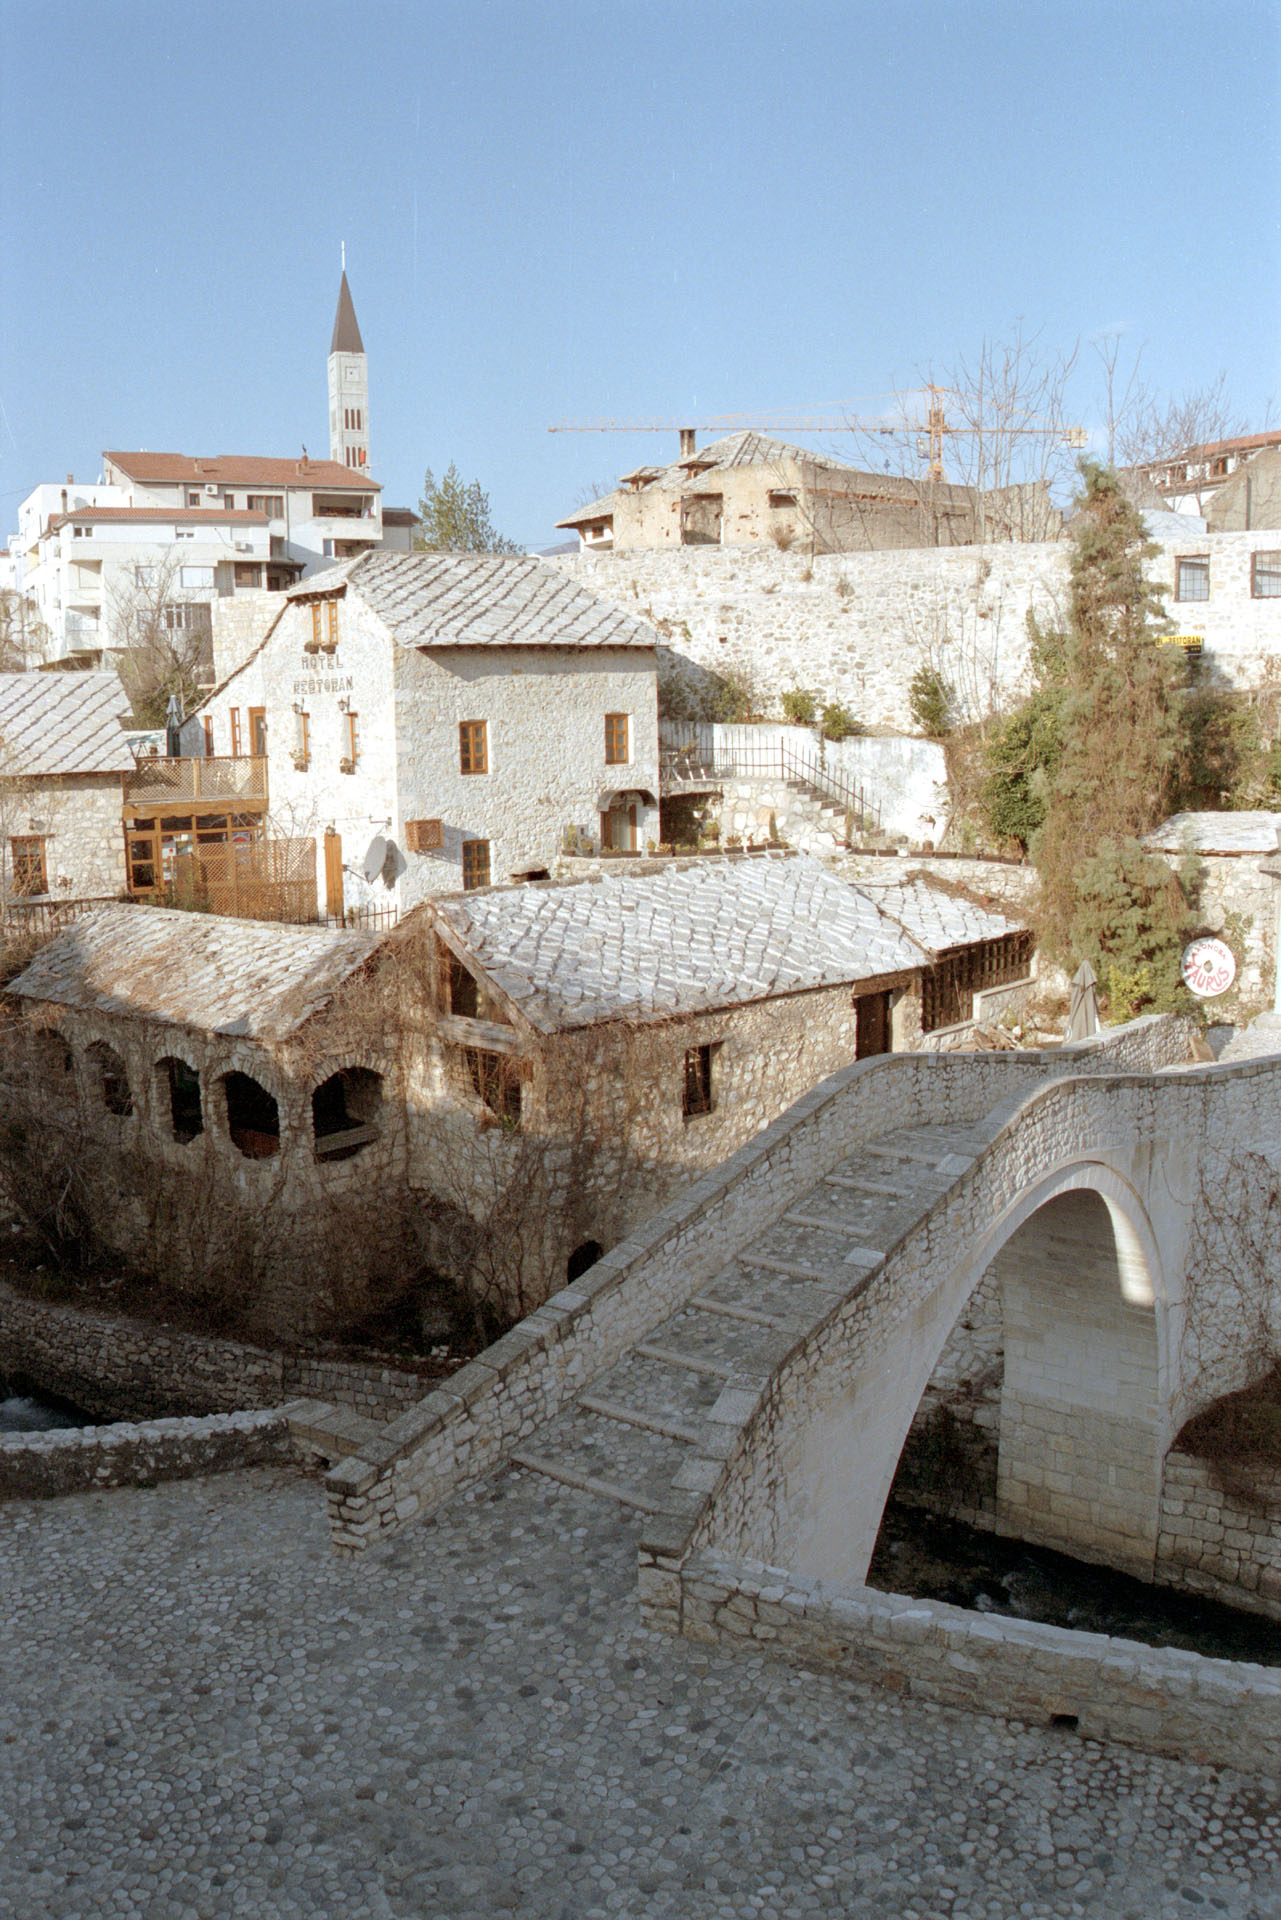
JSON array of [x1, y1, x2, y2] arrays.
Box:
[[511, 1100, 998, 1515]]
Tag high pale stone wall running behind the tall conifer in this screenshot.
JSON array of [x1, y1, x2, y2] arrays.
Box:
[[551, 532, 1281, 732]]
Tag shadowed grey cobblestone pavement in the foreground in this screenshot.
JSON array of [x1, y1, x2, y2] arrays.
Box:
[[0, 1469, 1281, 1920]]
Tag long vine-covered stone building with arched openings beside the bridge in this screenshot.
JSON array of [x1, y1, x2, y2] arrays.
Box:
[[0, 854, 1037, 1331]]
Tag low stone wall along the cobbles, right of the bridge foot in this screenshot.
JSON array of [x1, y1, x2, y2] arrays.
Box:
[[668, 1553, 1281, 1772]]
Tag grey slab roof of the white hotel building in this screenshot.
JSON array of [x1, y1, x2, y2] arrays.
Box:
[[301, 549, 659, 647]]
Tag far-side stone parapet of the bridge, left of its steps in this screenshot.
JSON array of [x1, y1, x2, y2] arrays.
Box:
[[326, 1018, 1187, 1551]]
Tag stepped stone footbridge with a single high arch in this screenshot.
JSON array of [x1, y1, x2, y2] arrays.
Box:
[[326, 1018, 1281, 1620]]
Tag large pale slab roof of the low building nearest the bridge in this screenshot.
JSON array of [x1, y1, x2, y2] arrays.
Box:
[[430, 854, 930, 1033]]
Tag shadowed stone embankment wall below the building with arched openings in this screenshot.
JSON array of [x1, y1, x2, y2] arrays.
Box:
[[0, 1284, 424, 1419]]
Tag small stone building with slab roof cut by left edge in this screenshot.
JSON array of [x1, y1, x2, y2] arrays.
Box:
[[0, 674, 134, 906]]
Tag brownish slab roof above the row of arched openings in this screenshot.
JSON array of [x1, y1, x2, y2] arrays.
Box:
[[10, 904, 380, 1041]]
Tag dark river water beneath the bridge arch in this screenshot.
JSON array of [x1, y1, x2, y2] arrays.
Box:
[[868, 1503, 1281, 1667]]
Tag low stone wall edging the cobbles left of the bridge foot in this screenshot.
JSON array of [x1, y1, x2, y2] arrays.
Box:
[[0, 1407, 294, 1500]]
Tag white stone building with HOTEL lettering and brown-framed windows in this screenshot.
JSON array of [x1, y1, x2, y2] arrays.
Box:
[[202, 553, 659, 914]]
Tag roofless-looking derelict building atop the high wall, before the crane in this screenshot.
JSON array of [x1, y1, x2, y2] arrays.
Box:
[[557, 432, 1060, 553]]
